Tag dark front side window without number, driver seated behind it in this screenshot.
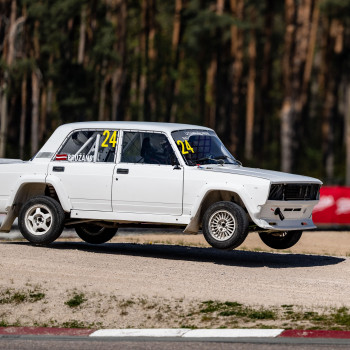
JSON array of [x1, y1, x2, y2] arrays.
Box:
[[121, 132, 176, 165]]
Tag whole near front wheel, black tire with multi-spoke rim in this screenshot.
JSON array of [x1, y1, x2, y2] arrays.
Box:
[[202, 201, 249, 250]]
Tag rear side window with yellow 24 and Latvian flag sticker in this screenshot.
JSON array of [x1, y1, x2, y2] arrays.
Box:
[[55, 130, 117, 163]]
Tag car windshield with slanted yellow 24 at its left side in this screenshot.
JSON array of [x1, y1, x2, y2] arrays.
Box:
[[171, 129, 240, 166]]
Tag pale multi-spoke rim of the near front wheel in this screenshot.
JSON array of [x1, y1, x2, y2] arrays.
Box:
[[209, 210, 236, 241]]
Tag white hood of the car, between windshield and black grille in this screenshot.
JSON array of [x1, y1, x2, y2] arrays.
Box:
[[203, 164, 322, 184]]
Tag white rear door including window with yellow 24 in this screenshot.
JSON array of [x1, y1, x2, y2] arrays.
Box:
[[48, 129, 118, 211]]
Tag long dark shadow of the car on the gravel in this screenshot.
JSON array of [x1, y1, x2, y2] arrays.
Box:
[[10, 242, 345, 269]]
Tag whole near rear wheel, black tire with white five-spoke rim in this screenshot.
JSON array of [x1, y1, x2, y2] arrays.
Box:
[[18, 196, 65, 245]]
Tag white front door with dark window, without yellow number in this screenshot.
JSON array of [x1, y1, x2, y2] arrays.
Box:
[[112, 131, 184, 215]]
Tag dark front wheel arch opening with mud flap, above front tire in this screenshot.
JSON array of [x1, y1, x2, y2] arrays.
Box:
[[184, 189, 251, 233]]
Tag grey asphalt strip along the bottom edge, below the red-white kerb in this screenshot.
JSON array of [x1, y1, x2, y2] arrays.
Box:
[[0, 335, 350, 350]]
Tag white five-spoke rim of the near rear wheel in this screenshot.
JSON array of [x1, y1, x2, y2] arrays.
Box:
[[24, 204, 52, 236]]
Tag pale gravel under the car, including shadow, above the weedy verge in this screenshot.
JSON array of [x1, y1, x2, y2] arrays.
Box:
[[0, 242, 350, 306]]
